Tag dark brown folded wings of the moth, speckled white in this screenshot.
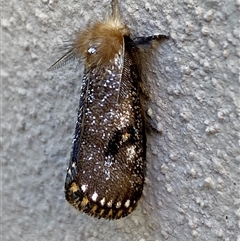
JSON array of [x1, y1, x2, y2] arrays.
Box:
[[65, 38, 146, 219]]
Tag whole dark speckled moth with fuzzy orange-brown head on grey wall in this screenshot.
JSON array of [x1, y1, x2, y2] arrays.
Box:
[[50, 0, 167, 219]]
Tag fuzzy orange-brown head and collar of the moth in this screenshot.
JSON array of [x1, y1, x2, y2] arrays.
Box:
[[74, 17, 130, 67]]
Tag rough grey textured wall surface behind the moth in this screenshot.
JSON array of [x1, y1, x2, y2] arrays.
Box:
[[1, 0, 240, 241]]
